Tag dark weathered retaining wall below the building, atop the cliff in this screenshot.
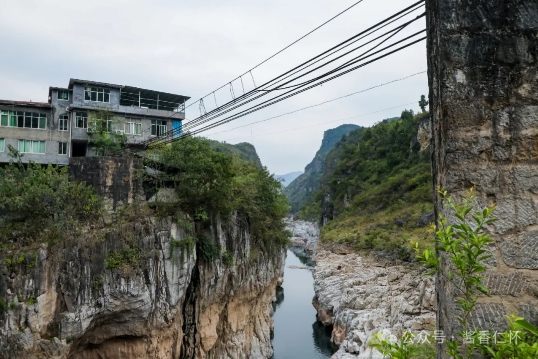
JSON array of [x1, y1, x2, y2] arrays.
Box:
[[69, 157, 144, 210]]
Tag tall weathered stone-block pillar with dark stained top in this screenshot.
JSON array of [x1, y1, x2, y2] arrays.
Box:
[[426, 0, 538, 354]]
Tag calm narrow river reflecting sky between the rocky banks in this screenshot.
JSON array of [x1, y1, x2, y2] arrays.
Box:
[[273, 251, 336, 359]]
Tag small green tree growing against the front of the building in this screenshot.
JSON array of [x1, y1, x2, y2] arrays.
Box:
[[88, 109, 127, 156]]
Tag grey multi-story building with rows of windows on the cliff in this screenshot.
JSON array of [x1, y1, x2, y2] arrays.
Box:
[[0, 79, 189, 165]]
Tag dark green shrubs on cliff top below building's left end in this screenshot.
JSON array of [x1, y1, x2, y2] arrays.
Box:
[[0, 146, 102, 249]]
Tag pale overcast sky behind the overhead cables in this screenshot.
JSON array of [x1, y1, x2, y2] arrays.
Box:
[[0, 0, 428, 174]]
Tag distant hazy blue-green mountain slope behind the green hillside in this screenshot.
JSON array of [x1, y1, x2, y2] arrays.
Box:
[[284, 125, 362, 213]]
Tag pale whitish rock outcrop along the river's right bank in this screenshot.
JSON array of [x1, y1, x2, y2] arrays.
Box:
[[313, 243, 436, 359]]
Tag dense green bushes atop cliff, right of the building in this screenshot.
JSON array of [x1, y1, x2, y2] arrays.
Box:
[[157, 137, 289, 253]]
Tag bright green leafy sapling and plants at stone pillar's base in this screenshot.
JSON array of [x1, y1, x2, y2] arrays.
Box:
[[372, 194, 538, 359]]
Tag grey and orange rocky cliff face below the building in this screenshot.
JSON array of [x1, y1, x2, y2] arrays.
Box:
[[0, 158, 285, 359]]
